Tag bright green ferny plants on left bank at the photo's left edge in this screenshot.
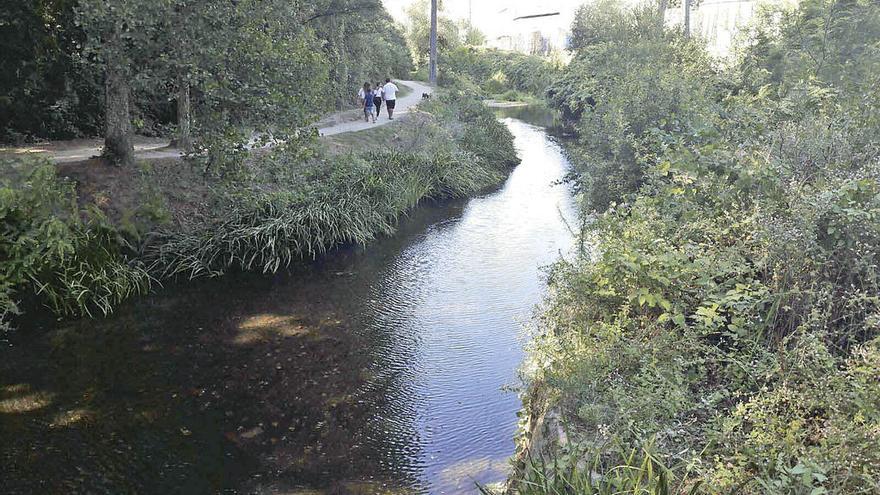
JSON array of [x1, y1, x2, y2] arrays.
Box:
[[0, 160, 151, 328]]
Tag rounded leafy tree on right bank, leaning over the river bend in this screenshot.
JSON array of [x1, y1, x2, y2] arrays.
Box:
[[547, 1, 719, 210]]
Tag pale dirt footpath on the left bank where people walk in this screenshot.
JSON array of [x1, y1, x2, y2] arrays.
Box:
[[0, 81, 433, 163]]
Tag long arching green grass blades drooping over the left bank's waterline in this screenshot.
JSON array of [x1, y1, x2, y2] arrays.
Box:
[[146, 147, 501, 278]]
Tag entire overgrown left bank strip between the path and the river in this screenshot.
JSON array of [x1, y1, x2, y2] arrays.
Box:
[[0, 96, 517, 334]]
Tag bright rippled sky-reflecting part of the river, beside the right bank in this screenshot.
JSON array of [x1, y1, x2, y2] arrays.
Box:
[[350, 120, 575, 493]]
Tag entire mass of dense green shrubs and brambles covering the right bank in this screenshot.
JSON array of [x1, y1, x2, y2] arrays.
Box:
[[519, 1, 880, 495]]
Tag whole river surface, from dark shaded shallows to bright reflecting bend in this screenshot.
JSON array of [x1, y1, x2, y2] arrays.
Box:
[[0, 109, 576, 494]]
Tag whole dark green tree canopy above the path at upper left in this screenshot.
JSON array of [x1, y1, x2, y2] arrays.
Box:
[[0, 0, 412, 145]]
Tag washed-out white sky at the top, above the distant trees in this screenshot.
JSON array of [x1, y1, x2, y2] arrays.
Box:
[[382, 0, 585, 39]]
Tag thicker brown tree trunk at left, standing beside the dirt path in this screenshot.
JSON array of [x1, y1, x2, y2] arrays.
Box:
[[104, 61, 134, 165]]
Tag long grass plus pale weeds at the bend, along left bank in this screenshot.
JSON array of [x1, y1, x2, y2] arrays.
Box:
[[146, 93, 517, 277]]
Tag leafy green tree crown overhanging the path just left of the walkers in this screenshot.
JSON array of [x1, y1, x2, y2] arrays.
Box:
[[154, 0, 328, 170]]
